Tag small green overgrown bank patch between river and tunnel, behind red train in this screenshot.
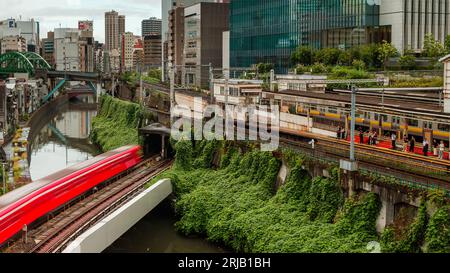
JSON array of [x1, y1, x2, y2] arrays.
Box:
[[90, 96, 143, 151]]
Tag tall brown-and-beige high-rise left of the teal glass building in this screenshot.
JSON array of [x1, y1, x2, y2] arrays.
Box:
[[182, 3, 229, 88]]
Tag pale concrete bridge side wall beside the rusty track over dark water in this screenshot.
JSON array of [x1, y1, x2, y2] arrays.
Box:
[[63, 179, 172, 253]]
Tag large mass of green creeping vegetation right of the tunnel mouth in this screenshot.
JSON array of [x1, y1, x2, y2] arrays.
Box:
[[151, 141, 379, 252]]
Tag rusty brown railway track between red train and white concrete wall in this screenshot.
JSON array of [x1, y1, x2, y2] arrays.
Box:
[[5, 158, 172, 253]]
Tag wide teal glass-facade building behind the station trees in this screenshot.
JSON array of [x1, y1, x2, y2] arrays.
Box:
[[230, 0, 390, 72]]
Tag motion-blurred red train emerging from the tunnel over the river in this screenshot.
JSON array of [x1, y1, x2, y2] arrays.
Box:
[[0, 146, 142, 245]]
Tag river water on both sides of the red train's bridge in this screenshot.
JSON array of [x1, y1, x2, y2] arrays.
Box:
[[30, 96, 224, 253]]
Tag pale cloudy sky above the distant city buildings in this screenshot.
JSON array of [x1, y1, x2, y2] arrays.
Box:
[[0, 0, 161, 42]]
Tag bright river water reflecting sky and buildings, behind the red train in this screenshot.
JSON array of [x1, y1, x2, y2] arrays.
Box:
[[30, 98, 98, 180]]
